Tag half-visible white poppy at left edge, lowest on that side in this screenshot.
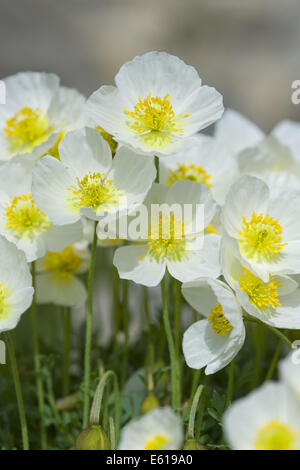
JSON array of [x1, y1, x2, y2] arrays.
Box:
[[0, 236, 33, 333]]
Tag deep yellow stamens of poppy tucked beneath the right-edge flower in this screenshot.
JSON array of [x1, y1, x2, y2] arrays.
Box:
[[238, 267, 281, 311]]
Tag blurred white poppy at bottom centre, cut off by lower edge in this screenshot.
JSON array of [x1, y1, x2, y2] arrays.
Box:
[[118, 407, 183, 450]]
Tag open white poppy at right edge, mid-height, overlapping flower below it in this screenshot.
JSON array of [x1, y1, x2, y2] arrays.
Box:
[[222, 176, 300, 282]]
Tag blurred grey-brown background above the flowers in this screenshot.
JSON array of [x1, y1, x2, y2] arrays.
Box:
[[0, 0, 300, 131]]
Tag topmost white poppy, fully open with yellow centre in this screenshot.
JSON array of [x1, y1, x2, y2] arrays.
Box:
[[87, 52, 223, 156]]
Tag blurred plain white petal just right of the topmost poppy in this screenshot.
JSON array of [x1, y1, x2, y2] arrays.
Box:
[[214, 109, 265, 156]]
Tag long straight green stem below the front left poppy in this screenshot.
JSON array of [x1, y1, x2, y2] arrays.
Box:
[[83, 221, 98, 429]]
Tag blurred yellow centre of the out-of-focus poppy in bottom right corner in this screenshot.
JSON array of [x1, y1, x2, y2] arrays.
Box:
[[255, 420, 298, 450]]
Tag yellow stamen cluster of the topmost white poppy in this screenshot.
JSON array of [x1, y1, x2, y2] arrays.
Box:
[[124, 93, 188, 134]]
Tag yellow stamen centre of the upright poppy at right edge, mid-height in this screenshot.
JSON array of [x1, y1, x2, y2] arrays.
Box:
[[239, 212, 287, 261]]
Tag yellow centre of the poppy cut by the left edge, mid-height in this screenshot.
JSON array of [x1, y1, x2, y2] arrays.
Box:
[[4, 194, 51, 239]]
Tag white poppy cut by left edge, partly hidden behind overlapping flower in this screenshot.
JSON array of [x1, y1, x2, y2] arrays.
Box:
[[0, 156, 82, 262]]
